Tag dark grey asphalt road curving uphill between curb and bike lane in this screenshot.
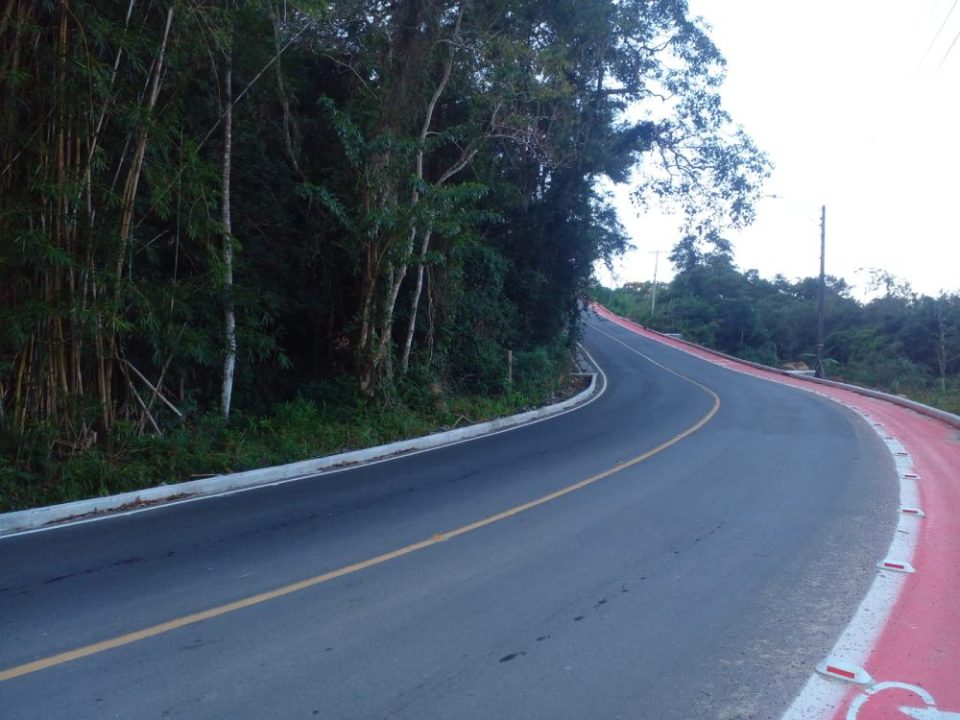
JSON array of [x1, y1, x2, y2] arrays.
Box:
[[0, 320, 897, 720]]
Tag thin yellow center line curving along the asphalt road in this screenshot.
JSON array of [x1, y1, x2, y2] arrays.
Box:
[[0, 329, 720, 682]]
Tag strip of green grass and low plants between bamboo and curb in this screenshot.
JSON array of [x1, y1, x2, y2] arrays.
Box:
[[0, 354, 574, 512]]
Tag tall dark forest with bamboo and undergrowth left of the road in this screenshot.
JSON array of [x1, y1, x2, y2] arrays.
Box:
[[0, 0, 767, 510]]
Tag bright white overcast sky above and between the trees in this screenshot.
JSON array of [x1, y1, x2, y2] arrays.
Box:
[[600, 0, 960, 296]]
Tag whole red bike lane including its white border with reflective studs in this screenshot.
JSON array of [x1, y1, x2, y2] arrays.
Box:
[[593, 306, 960, 720]]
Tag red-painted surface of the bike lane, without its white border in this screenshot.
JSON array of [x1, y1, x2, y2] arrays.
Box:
[[594, 306, 960, 720]]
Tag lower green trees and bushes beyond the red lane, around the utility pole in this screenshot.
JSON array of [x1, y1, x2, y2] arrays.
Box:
[[593, 232, 960, 413]]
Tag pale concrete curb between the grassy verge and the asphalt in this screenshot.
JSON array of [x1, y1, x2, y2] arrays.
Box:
[[0, 358, 603, 536]]
